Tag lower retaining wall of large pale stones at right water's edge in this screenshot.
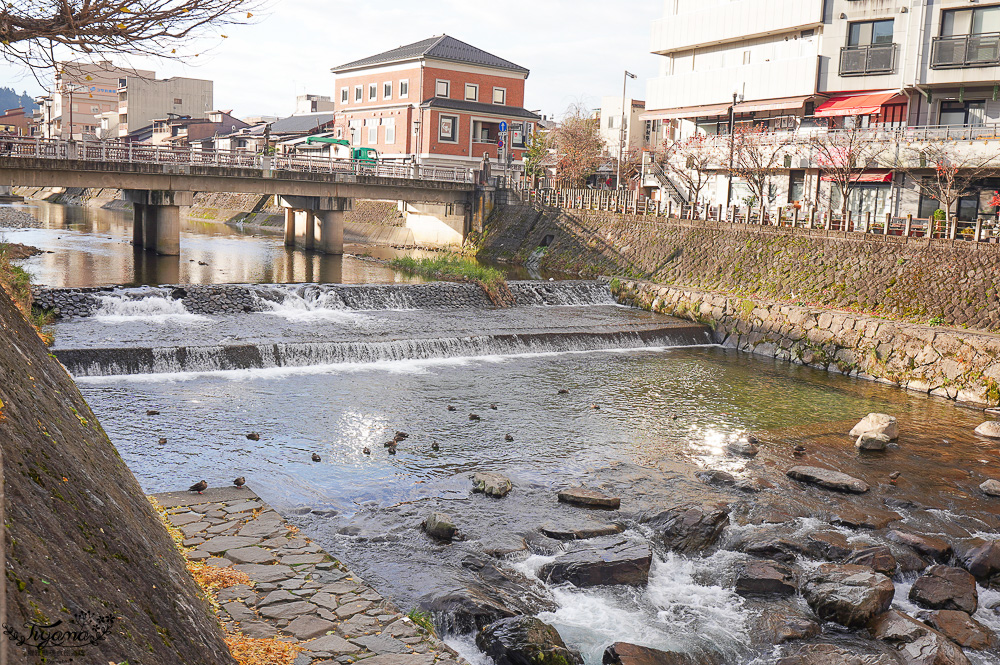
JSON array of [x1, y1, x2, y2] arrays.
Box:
[[611, 279, 1000, 407]]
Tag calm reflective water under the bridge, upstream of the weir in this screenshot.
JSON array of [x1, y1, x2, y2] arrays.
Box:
[[0, 201, 450, 287]]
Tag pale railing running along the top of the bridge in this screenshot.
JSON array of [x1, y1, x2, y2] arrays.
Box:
[[0, 136, 474, 183]]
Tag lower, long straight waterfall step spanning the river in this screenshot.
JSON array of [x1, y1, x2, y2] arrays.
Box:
[[56, 326, 711, 377]]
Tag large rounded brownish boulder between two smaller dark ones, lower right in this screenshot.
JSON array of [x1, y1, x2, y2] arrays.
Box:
[[802, 563, 895, 628]]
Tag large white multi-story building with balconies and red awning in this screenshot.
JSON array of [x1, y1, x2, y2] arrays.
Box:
[[643, 0, 1000, 218]]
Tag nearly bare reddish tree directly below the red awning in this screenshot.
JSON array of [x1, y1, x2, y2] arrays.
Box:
[[809, 118, 890, 218]]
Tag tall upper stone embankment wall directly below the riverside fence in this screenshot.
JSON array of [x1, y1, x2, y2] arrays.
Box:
[[479, 205, 1000, 331]]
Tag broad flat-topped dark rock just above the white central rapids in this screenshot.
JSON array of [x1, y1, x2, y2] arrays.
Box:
[[538, 538, 652, 587]]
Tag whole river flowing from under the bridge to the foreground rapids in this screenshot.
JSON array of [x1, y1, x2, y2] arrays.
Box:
[[1, 202, 1000, 665]]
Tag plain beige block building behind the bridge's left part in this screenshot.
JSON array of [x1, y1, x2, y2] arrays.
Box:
[[115, 72, 215, 137]]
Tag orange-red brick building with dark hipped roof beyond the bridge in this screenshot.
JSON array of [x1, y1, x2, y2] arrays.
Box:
[[331, 35, 539, 168]]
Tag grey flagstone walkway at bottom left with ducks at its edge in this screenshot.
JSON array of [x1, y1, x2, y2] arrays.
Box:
[[154, 487, 467, 665]]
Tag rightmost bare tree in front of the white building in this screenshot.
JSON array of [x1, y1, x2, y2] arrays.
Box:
[[896, 142, 998, 228]]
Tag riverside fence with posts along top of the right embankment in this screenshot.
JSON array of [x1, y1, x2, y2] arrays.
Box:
[[507, 189, 1000, 243]]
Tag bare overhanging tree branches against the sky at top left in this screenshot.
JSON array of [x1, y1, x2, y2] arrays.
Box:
[[0, 0, 260, 69]]
